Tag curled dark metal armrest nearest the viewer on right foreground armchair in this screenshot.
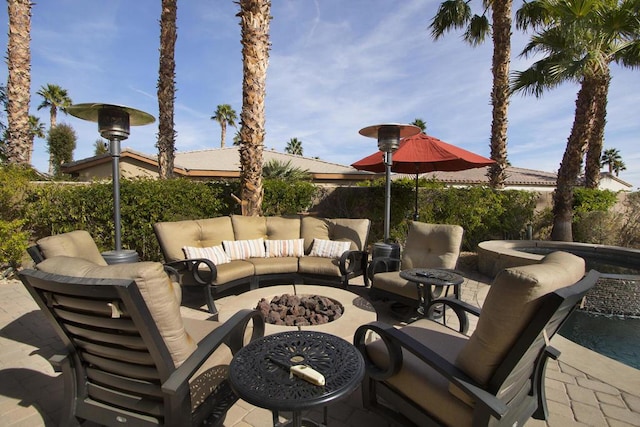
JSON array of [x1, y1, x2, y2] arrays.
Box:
[[353, 322, 508, 420]]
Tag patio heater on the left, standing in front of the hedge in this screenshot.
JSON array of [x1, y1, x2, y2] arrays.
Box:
[[66, 103, 155, 264]]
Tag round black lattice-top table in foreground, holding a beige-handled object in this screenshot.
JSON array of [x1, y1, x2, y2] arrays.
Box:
[[229, 331, 364, 427]]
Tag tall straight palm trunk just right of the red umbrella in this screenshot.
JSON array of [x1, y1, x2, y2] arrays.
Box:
[[488, 0, 512, 189]]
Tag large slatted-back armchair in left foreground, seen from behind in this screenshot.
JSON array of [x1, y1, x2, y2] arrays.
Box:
[[19, 256, 264, 426]]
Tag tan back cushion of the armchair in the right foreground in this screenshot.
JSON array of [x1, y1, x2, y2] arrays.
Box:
[[456, 252, 585, 385]]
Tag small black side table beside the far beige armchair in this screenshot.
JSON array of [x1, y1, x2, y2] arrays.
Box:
[[400, 268, 464, 315]]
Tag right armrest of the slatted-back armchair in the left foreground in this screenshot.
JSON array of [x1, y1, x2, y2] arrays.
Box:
[[162, 309, 264, 395]]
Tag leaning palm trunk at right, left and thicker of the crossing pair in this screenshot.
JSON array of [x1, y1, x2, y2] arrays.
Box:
[[551, 78, 597, 242]]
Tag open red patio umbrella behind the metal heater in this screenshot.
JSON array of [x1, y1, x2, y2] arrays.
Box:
[[351, 133, 494, 220]]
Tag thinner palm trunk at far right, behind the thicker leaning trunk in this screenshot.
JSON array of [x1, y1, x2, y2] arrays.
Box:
[[584, 73, 611, 188]]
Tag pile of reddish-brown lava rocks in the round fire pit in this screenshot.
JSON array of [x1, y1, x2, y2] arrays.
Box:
[[256, 294, 344, 326]]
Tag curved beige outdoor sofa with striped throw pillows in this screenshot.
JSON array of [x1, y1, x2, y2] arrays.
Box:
[[153, 215, 371, 316]]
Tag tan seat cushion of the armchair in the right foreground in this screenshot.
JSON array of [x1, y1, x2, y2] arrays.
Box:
[[367, 319, 473, 426]]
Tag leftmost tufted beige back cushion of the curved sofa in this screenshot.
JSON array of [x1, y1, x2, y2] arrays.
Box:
[[153, 216, 235, 262]]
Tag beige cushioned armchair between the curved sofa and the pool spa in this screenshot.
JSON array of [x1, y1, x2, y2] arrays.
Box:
[[368, 221, 464, 308]]
